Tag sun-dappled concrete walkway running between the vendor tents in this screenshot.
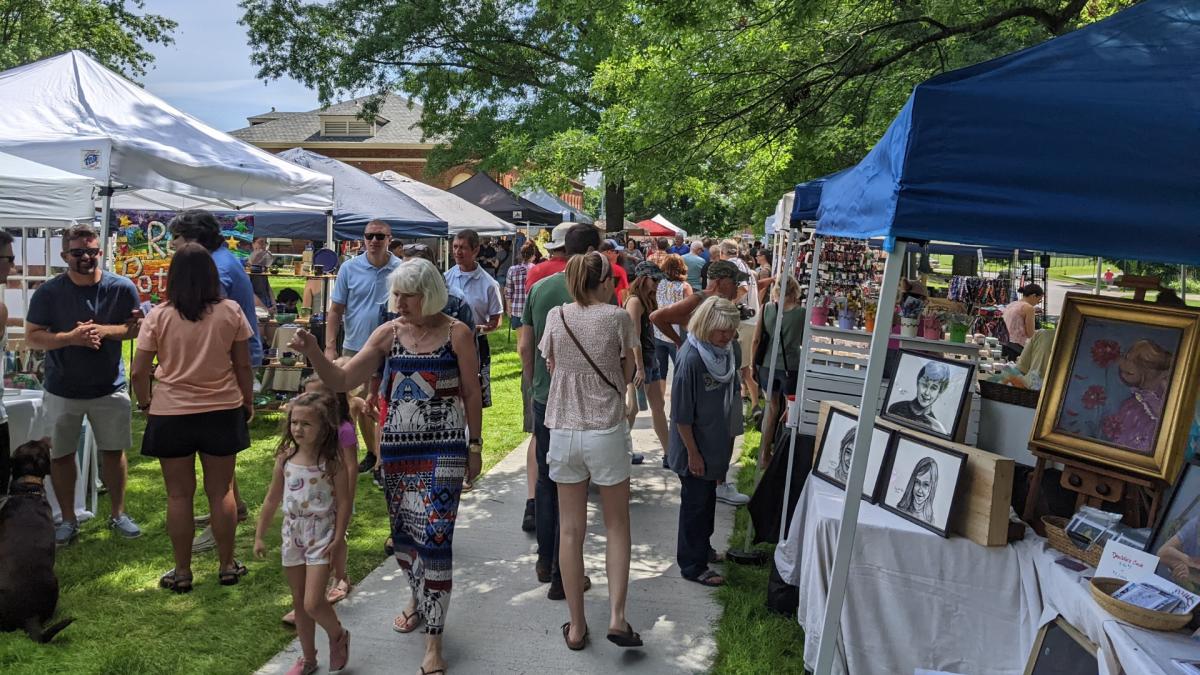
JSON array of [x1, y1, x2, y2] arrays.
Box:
[[259, 413, 733, 675]]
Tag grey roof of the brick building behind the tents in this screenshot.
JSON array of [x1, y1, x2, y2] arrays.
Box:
[[229, 94, 436, 145]]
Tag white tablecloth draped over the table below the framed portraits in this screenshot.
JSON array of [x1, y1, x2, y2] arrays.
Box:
[[775, 478, 1200, 675]]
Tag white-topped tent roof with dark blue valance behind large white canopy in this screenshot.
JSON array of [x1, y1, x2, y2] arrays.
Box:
[[254, 148, 446, 240]]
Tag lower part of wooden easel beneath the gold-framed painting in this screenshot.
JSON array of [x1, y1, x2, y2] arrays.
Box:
[[1021, 448, 1166, 532]]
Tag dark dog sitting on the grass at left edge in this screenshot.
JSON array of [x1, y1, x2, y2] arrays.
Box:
[[0, 438, 73, 643]]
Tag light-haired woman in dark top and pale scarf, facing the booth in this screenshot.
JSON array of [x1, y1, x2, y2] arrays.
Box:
[[667, 297, 743, 586]]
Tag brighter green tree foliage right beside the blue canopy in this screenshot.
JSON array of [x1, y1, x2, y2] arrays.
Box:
[[595, 0, 1134, 223]]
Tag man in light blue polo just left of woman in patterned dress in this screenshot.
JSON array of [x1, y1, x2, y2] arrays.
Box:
[[325, 220, 400, 360]]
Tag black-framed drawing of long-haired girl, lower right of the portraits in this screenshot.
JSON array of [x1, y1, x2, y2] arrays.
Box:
[[880, 431, 967, 537]]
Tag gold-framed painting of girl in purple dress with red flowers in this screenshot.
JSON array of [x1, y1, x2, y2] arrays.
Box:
[[1030, 293, 1200, 483]]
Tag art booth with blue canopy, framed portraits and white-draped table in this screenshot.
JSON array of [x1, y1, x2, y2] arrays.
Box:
[[768, 0, 1200, 675]]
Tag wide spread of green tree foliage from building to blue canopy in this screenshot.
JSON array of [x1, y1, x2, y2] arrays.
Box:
[[241, 0, 1135, 231]]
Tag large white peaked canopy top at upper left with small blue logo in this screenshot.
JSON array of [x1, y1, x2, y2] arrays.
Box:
[[0, 50, 334, 246]]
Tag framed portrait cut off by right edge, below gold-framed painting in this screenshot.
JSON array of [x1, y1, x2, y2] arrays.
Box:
[[1147, 460, 1200, 593]]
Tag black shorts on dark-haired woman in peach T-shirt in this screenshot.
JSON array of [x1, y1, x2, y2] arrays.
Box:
[[142, 406, 250, 459]]
